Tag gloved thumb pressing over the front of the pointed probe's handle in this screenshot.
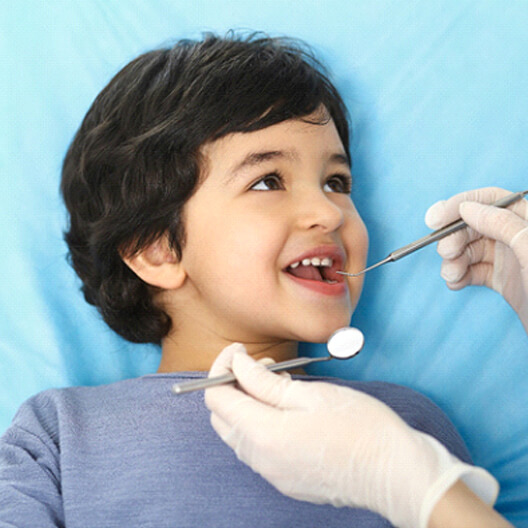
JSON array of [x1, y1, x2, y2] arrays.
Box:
[[460, 202, 528, 268]]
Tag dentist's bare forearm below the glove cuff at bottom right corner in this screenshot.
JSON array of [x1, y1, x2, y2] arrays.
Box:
[[427, 480, 513, 528]]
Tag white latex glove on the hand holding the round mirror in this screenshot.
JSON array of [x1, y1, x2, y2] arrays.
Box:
[[205, 344, 498, 528]]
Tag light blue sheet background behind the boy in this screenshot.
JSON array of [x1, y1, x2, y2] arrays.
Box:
[[0, 0, 528, 526]]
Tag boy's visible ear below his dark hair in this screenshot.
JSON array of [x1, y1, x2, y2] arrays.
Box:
[[123, 236, 186, 290]]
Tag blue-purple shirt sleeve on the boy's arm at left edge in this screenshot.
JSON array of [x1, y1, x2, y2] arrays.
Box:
[[0, 396, 65, 528]]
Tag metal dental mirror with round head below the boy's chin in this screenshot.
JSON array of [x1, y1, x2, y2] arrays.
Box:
[[172, 327, 365, 394]]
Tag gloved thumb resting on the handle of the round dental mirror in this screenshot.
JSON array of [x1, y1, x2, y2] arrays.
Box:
[[231, 354, 302, 408]]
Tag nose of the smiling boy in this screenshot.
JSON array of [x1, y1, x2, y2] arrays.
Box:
[[296, 189, 345, 233]]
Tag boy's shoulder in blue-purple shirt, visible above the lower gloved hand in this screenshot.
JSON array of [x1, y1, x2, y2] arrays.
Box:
[[308, 378, 471, 463]]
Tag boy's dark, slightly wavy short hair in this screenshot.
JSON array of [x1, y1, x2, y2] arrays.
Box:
[[61, 32, 350, 344]]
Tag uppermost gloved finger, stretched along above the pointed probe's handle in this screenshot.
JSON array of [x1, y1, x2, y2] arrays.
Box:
[[425, 187, 511, 229]]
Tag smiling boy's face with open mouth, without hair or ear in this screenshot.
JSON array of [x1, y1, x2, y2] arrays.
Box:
[[180, 111, 368, 343]]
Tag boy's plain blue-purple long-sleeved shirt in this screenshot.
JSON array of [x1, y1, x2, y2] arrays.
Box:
[[0, 372, 470, 528]]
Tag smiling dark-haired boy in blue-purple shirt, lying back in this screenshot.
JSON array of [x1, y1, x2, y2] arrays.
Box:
[[0, 35, 469, 528]]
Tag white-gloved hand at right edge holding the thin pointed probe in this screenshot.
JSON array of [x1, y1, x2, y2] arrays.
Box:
[[425, 187, 528, 332]]
